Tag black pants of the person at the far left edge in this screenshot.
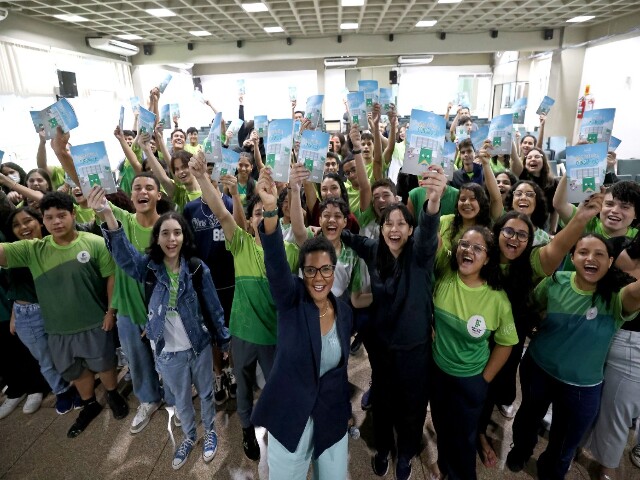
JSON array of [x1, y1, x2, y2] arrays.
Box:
[[0, 321, 50, 398]]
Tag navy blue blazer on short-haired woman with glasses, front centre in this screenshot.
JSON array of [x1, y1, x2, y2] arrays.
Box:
[[251, 224, 352, 458]]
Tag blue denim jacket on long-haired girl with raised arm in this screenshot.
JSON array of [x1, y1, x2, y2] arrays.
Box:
[[102, 225, 231, 355]]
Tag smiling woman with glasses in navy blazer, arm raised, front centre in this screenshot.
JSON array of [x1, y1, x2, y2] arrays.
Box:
[[252, 169, 352, 480]]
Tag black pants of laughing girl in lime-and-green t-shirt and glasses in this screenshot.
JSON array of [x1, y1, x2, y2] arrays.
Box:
[[431, 364, 489, 480]]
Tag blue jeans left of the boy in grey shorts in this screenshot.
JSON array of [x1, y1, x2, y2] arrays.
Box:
[[13, 303, 69, 395]]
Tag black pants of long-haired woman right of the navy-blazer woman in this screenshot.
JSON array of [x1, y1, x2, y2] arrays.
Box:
[[364, 335, 431, 460]]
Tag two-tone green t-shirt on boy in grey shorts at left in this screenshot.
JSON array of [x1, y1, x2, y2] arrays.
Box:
[[2, 232, 115, 335]]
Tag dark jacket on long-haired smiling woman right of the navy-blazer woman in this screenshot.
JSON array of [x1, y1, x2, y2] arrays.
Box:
[[342, 201, 440, 350]]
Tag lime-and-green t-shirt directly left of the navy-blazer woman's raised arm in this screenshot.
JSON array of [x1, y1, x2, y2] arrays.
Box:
[[225, 227, 298, 345]]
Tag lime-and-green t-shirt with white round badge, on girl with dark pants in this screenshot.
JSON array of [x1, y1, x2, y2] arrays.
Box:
[[433, 269, 518, 377]]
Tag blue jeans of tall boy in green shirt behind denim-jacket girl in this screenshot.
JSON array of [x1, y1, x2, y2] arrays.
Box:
[[117, 315, 162, 403]]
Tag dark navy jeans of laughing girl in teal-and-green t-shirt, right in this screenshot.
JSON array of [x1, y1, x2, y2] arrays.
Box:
[[513, 352, 602, 480]]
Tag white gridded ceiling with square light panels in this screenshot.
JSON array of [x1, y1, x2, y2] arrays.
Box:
[[0, 0, 640, 44]]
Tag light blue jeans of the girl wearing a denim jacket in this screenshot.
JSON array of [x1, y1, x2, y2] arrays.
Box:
[[156, 345, 216, 441]]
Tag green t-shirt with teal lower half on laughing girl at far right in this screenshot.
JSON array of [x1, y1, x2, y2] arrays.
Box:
[[529, 272, 636, 386]]
